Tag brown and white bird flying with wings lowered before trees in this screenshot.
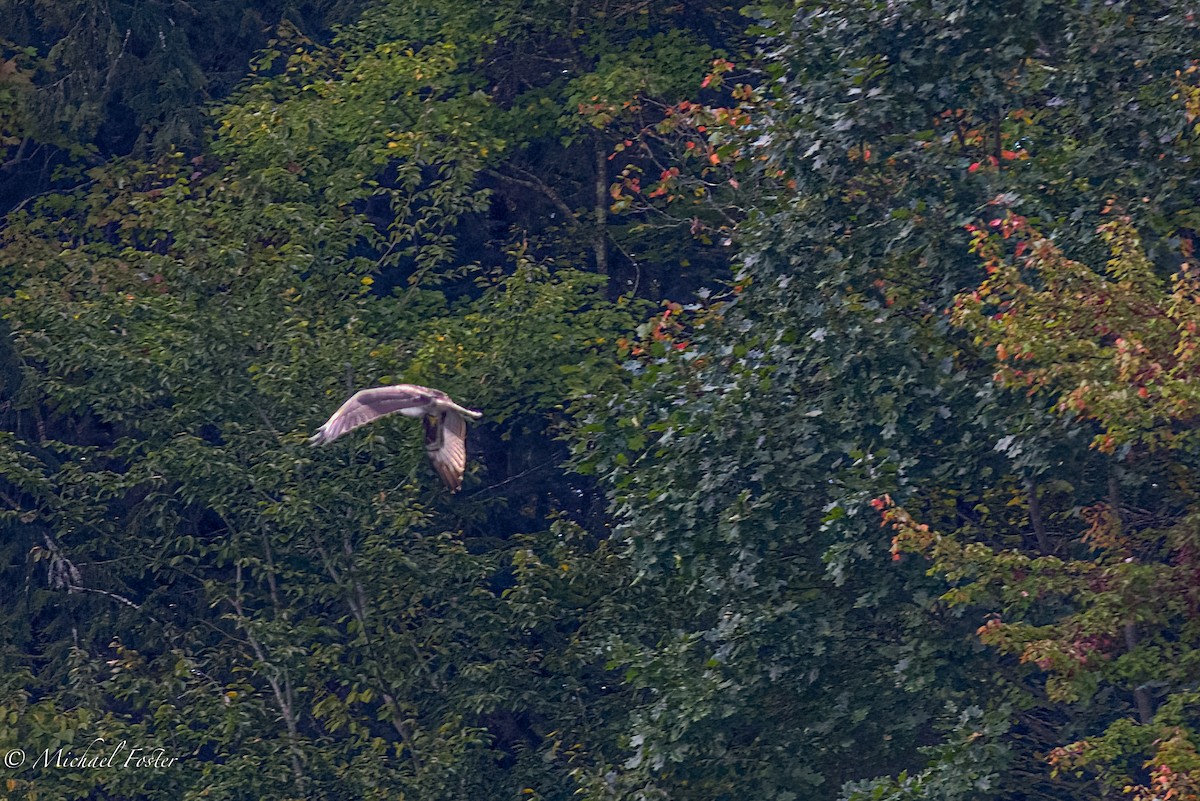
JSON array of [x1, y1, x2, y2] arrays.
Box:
[[308, 384, 484, 493]]
